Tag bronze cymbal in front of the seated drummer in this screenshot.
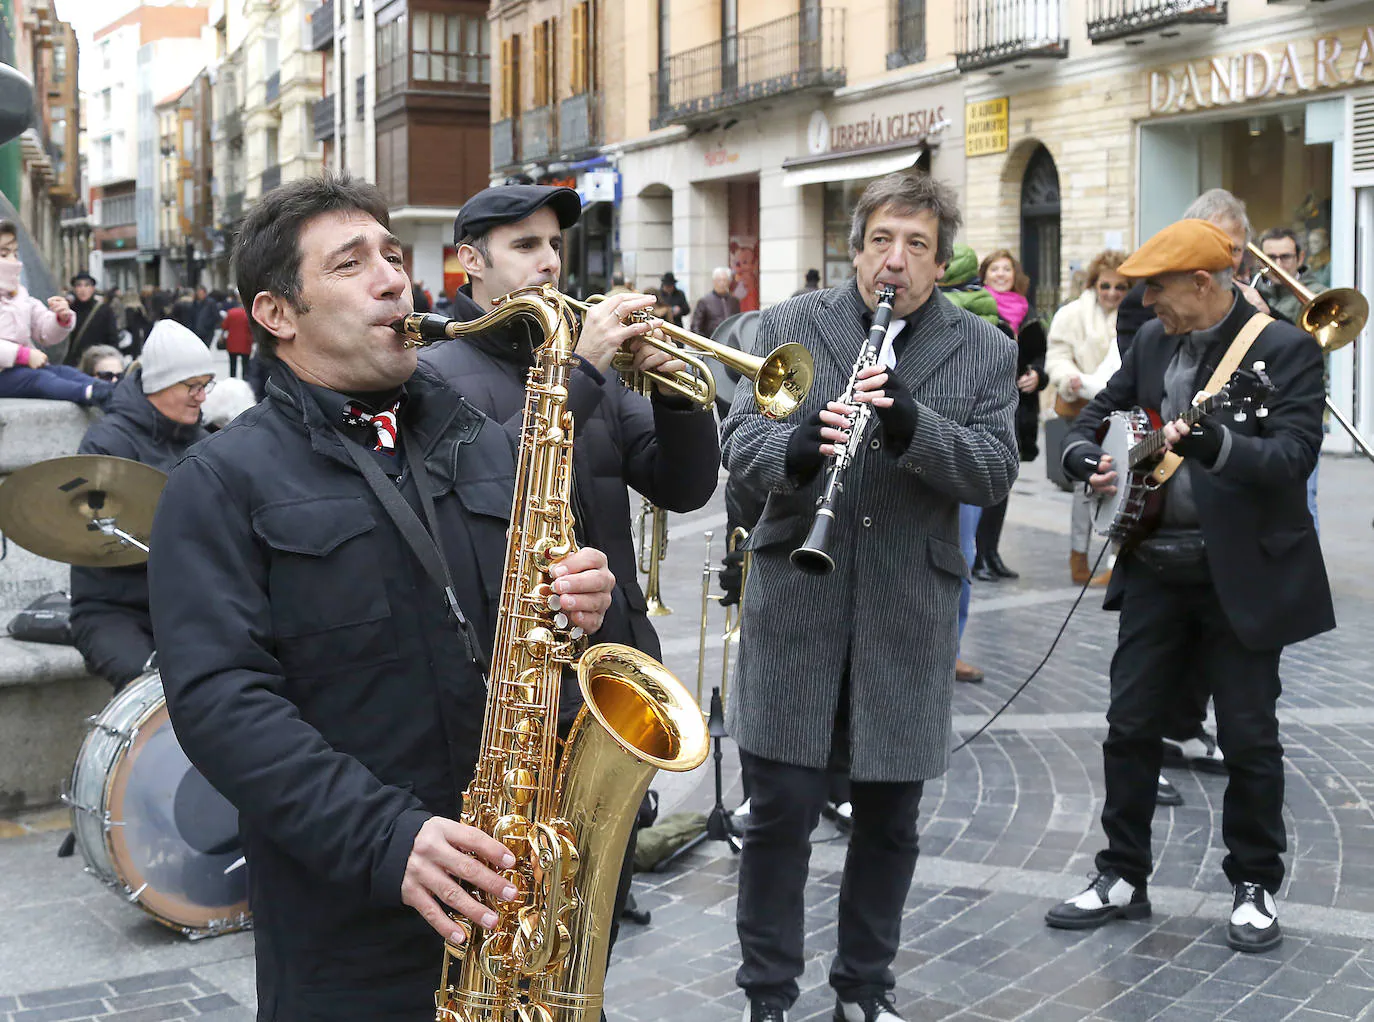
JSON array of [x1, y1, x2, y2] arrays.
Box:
[[0, 455, 168, 567]]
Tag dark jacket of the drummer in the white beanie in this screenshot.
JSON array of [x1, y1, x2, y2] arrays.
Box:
[[71, 370, 206, 691]]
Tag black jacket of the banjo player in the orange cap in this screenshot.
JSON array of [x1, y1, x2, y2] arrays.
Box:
[[1065, 293, 1336, 650]]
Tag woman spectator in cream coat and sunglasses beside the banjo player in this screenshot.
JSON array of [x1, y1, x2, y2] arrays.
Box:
[[1044, 250, 1131, 587]]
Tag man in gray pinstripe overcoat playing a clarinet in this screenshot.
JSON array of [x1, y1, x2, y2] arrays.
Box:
[[723, 174, 1018, 1022]]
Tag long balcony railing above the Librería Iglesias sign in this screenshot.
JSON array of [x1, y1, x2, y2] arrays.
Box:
[[649, 8, 845, 128]]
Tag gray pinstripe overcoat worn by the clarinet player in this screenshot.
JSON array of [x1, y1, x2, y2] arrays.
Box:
[[721, 279, 1018, 782]]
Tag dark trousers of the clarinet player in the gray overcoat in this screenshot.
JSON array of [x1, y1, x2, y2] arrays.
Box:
[[735, 750, 923, 1008]]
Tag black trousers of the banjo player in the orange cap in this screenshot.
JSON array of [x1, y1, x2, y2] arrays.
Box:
[[1096, 560, 1287, 893]]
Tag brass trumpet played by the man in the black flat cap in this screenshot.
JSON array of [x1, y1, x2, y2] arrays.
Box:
[[563, 294, 816, 419]]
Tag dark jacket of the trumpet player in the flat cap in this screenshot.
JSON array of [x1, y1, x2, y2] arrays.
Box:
[[420, 290, 720, 657]]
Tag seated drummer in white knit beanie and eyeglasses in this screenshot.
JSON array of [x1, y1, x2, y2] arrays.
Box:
[[71, 320, 214, 692]]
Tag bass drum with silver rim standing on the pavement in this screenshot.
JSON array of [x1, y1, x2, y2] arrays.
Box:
[[63, 670, 251, 940]]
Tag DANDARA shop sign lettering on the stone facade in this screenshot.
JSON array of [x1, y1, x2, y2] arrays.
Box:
[[1150, 27, 1374, 114]]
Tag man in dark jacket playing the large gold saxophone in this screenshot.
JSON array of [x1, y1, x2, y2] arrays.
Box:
[[148, 176, 614, 1022]]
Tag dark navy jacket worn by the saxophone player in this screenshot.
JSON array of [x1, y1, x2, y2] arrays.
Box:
[[148, 364, 515, 1022]]
